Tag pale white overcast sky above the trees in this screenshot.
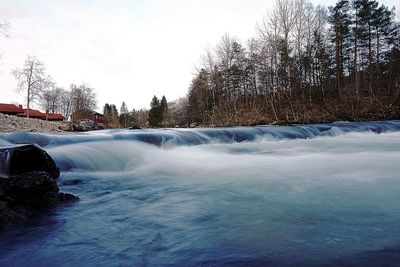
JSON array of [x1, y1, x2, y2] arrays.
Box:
[[0, 0, 400, 111]]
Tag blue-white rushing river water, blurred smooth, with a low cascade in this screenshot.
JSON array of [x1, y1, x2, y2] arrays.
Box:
[[0, 121, 400, 266]]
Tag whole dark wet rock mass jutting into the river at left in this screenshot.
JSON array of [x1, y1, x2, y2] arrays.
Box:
[[0, 145, 79, 229]]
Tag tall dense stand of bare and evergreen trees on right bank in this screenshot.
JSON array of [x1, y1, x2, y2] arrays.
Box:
[[181, 0, 400, 125]]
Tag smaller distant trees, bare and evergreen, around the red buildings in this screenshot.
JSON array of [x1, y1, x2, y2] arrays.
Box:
[[12, 56, 170, 128]]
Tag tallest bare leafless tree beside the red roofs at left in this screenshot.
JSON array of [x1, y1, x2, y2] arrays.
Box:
[[12, 56, 53, 118]]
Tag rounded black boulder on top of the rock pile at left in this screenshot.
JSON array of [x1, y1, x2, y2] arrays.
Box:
[[0, 144, 60, 179]]
